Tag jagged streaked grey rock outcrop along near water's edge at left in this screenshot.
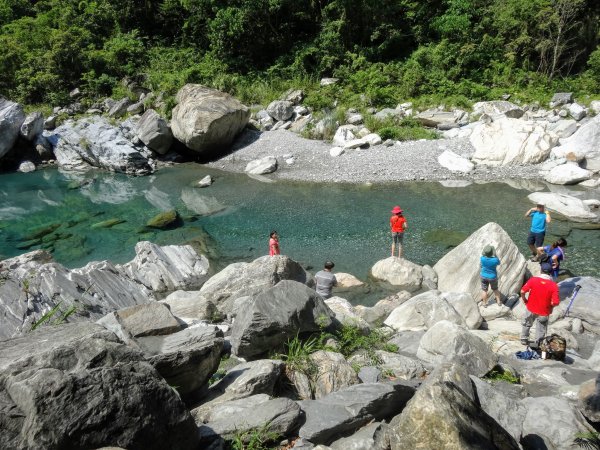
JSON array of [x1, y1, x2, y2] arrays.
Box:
[[0, 243, 208, 338]]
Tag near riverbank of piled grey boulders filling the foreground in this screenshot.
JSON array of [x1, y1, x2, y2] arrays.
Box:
[[0, 223, 600, 450]]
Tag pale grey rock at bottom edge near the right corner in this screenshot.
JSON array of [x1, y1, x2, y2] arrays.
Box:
[[521, 397, 592, 450]]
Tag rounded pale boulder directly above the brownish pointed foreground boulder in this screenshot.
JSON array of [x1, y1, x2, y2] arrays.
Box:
[[417, 320, 498, 377]]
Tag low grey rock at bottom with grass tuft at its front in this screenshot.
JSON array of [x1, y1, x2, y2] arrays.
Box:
[[198, 398, 302, 442]]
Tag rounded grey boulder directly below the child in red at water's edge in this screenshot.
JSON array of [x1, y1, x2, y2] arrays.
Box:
[[200, 255, 314, 314]]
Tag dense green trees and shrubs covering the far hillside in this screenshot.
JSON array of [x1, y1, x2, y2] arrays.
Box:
[[0, 0, 600, 107]]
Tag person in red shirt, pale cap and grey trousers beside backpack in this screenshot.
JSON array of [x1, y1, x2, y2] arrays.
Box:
[[521, 263, 560, 345]]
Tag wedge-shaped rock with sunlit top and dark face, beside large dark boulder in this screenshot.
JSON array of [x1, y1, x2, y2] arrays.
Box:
[[136, 325, 223, 397]]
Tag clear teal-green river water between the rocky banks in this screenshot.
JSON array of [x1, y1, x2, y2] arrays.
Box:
[[0, 164, 600, 303]]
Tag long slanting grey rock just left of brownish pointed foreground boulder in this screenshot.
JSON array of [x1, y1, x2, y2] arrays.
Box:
[[298, 383, 415, 444]]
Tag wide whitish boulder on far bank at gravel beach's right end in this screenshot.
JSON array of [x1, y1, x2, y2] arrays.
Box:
[[470, 118, 557, 166]]
